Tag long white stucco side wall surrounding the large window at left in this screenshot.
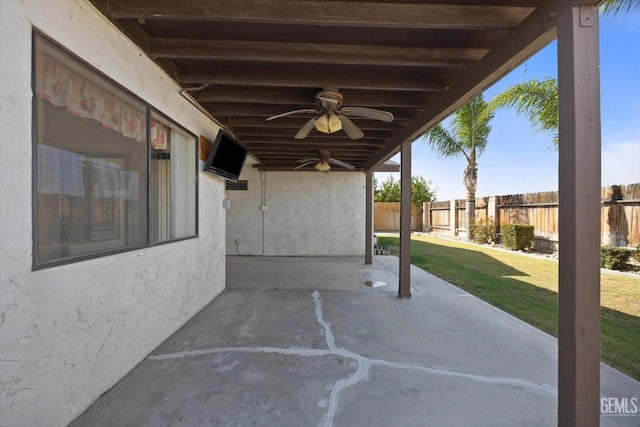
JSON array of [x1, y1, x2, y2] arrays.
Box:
[[0, 0, 225, 427]]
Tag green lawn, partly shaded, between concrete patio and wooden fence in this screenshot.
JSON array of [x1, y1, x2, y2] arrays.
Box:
[[378, 235, 640, 380]]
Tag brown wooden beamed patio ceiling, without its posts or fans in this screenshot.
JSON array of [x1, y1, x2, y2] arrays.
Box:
[[90, 0, 597, 174]]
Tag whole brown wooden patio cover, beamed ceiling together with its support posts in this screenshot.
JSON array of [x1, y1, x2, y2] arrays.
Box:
[[89, 0, 601, 426]]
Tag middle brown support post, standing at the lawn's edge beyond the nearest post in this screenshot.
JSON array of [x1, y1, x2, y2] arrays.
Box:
[[398, 142, 411, 298]]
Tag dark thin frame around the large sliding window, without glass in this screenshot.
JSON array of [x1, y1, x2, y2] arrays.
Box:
[[31, 32, 200, 271]]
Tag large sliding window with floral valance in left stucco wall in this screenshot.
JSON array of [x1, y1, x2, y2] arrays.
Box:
[[33, 35, 197, 267]]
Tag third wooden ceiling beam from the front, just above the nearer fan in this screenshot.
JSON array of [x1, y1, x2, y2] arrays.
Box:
[[178, 67, 446, 92]]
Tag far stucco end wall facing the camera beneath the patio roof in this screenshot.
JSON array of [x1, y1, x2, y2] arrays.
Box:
[[226, 159, 365, 256]]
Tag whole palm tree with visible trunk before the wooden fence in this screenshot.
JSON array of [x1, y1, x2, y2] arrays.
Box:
[[423, 94, 493, 240]]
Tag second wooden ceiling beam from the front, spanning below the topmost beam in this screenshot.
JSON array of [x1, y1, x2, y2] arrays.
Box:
[[150, 39, 488, 67]]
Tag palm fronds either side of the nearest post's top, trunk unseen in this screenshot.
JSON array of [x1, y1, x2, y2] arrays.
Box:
[[490, 0, 640, 149]]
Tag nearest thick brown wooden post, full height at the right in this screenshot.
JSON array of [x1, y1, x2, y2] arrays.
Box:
[[558, 7, 601, 427]]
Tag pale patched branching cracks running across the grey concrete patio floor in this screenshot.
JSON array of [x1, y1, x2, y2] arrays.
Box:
[[147, 291, 557, 427]]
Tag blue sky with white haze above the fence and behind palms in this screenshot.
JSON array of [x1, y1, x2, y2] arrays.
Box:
[[376, 9, 640, 200]]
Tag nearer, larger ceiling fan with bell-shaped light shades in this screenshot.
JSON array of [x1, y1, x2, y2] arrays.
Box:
[[267, 89, 393, 139]]
